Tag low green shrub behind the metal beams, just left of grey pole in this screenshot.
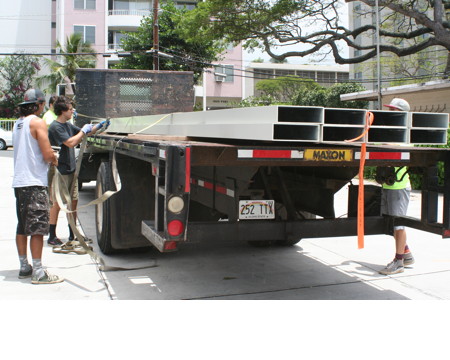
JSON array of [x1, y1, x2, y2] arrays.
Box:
[[295, 83, 369, 109]]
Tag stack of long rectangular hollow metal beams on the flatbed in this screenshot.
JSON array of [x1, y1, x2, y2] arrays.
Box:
[[108, 106, 449, 145]]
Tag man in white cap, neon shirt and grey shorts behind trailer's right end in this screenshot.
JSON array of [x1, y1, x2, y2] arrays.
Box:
[[379, 98, 414, 275]]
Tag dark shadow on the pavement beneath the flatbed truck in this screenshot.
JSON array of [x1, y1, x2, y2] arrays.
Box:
[[79, 187, 407, 300]]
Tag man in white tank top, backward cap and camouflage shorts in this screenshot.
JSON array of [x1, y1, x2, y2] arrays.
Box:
[[12, 89, 64, 284]]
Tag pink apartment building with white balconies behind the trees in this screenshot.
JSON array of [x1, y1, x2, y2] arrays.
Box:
[[51, 0, 244, 109]]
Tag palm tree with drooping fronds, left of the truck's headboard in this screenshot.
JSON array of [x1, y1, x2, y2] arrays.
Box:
[[36, 33, 96, 94]]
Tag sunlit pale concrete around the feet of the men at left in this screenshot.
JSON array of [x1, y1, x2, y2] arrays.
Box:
[[0, 149, 110, 300]]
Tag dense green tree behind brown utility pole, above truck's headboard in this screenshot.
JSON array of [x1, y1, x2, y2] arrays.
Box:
[[116, 1, 225, 81]]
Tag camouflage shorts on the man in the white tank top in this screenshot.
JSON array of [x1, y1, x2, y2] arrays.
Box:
[[14, 186, 50, 236]]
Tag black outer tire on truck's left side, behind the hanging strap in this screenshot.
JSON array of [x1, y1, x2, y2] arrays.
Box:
[[95, 162, 115, 255]]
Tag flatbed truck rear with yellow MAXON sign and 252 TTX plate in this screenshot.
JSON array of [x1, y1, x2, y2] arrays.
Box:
[[83, 134, 450, 254]]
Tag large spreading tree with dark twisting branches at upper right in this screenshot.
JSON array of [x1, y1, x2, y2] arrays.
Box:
[[179, 0, 450, 70]]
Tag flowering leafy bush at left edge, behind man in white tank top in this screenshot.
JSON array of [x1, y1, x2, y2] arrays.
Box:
[[0, 55, 40, 118]]
